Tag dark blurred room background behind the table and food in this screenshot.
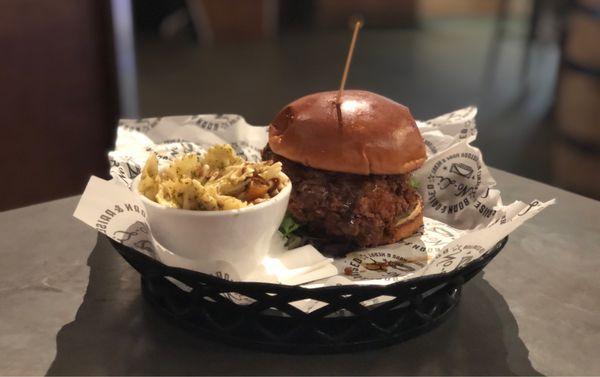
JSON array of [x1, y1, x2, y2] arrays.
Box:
[[0, 0, 600, 210]]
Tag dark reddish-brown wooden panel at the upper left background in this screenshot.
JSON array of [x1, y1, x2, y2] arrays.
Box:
[[0, 0, 117, 210]]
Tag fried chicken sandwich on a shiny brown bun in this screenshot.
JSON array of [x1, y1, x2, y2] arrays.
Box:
[[263, 90, 426, 254]]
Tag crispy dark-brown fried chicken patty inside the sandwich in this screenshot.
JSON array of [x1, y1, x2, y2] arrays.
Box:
[[263, 146, 420, 247]]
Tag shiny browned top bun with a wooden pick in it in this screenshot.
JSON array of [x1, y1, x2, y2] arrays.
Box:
[[269, 90, 426, 175]]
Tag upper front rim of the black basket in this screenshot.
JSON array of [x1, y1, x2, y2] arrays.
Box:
[[103, 235, 508, 299]]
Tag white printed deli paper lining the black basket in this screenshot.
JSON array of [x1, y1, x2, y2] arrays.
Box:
[[74, 107, 554, 311]]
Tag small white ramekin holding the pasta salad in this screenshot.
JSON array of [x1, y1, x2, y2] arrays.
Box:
[[132, 176, 292, 279]]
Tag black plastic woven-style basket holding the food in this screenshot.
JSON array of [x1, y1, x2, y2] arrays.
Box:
[[111, 237, 508, 353]]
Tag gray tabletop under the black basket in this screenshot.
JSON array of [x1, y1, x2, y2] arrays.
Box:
[[0, 170, 600, 375]]
